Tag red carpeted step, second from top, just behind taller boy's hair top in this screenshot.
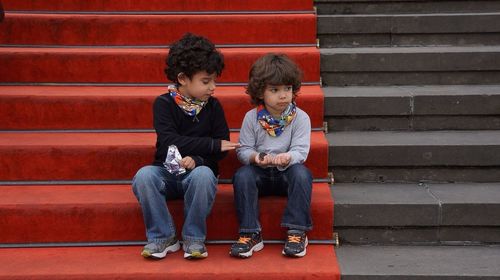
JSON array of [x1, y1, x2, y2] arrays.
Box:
[[0, 13, 316, 46]]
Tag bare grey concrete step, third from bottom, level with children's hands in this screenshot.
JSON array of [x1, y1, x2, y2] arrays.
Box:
[[326, 130, 500, 182]]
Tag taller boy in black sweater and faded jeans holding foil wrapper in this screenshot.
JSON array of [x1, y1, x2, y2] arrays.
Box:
[[132, 33, 238, 259]]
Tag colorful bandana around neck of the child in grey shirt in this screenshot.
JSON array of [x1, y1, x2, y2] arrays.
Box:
[[257, 102, 296, 137]]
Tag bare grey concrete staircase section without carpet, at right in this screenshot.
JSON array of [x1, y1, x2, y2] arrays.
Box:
[[315, 0, 500, 280]]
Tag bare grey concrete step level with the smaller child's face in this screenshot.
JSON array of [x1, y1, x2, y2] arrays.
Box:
[[323, 85, 500, 131]]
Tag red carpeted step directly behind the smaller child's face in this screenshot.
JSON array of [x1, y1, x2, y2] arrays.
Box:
[[0, 86, 324, 130]]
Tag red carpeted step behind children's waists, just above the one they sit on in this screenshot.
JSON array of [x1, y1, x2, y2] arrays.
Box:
[[0, 131, 328, 181]]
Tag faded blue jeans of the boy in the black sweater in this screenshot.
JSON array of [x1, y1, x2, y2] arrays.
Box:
[[132, 165, 217, 242]]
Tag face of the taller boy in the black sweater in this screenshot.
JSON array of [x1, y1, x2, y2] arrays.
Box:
[[178, 71, 217, 101]]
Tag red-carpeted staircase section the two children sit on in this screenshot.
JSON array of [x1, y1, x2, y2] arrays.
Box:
[[0, 0, 340, 279]]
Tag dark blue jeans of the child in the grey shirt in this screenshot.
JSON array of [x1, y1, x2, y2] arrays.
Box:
[[233, 164, 312, 232]]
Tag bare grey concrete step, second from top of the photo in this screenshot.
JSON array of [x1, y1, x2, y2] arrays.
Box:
[[318, 12, 500, 48]]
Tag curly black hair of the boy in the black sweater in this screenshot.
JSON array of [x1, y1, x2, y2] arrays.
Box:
[[165, 33, 224, 86]]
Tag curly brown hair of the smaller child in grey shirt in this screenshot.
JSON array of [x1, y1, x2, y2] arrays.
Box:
[[246, 53, 302, 105]]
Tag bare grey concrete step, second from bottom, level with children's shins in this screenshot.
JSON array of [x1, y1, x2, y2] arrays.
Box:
[[331, 182, 500, 245]]
